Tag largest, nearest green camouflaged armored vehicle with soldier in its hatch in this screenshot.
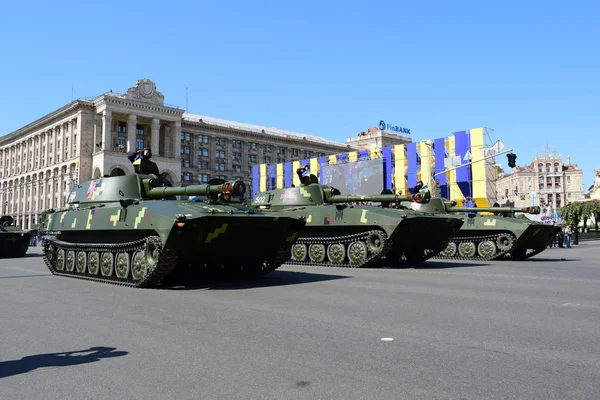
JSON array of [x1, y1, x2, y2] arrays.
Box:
[[40, 174, 305, 288]]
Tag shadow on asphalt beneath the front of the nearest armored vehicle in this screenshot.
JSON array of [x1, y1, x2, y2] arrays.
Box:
[[163, 270, 349, 290]]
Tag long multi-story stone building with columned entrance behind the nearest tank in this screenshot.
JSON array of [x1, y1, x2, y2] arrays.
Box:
[[0, 79, 349, 229]]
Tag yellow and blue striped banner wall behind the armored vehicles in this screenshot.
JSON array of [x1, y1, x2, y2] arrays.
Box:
[[252, 128, 494, 207]]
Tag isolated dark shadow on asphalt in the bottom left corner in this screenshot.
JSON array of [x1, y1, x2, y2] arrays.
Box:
[[0, 347, 129, 378]]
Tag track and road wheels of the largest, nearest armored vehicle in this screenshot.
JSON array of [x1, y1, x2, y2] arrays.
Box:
[[43, 236, 178, 288]]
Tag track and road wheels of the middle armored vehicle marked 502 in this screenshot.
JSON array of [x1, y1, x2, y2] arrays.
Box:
[[287, 230, 393, 268]]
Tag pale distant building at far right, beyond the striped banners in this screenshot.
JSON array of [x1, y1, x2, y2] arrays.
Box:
[[496, 153, 584, 208]]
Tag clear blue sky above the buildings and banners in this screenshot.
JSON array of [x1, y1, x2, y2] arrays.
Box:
[[0, 0, 600, 189]]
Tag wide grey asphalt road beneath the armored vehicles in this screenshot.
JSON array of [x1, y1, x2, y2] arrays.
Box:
[[0, 242, 600, 400]]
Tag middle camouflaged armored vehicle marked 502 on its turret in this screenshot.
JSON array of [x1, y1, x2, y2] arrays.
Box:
[[252, 183, 462, 268]]
